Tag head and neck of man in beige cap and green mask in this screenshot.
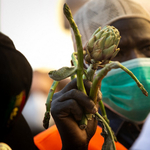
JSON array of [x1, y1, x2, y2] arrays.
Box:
[[74, 0, 150, 148]]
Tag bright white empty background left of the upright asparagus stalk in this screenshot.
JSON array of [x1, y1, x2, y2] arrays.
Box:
[[0, 0, 73, 69]]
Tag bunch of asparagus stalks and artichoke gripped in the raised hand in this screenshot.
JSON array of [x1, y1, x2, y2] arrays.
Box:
[[43, 4, 148, 150]]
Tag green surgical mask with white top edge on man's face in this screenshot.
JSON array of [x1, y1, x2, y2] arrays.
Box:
[[101, 58, 150, 122]]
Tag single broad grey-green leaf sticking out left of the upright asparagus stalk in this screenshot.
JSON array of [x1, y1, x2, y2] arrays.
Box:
[[49, 66, 77, 81]]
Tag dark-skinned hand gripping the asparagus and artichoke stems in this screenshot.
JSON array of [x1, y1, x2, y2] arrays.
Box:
[[51, 79, 101, 150]]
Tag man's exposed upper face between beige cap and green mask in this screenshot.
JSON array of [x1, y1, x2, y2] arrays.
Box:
[[112, 18, 150, 62]]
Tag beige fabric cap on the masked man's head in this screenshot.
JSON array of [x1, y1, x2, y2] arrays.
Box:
[[74, 0, 150, 44]]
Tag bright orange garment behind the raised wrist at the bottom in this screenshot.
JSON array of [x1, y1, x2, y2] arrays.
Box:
[[34, 125, 127, 150]]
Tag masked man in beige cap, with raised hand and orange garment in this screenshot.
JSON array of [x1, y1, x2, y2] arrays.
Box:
[[34, 0, 150, 150]]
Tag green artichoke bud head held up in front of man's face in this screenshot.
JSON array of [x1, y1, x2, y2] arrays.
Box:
[[86, 26, 121, 64]]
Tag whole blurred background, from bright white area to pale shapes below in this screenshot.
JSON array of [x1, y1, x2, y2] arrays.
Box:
[[0, 0, 150, 135]]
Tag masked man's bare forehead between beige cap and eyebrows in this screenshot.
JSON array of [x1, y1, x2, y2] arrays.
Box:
[[112, 18, 150, 44]]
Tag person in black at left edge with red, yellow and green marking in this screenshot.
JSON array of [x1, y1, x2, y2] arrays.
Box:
[[0, 32, 37, 150]]
